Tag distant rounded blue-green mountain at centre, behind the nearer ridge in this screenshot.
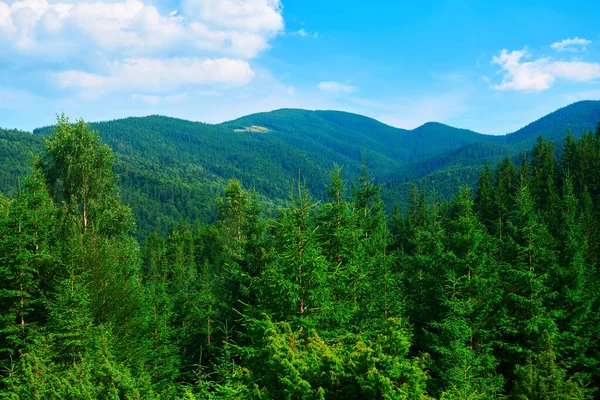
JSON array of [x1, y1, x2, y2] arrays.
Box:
[[223, 109, 499, 163]]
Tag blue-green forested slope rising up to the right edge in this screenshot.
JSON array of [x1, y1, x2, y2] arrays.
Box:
[[383, 101, 600, 205]]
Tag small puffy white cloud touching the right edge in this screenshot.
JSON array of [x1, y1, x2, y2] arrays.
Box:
[[492, 49, 600, 91]]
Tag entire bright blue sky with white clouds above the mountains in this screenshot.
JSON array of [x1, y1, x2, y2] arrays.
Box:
[[0, 0, 600, 134]]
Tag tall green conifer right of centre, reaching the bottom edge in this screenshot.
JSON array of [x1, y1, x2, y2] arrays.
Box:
[[431, 188, 502, 399]]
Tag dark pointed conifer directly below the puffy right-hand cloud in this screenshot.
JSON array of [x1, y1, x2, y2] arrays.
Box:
[[499, 181, 558, 380]]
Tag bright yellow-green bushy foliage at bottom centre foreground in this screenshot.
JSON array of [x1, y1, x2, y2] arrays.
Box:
[[237, 317, 428, 399]]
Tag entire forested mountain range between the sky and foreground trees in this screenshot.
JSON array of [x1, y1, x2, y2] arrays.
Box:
[[0, 101, 600, 237]]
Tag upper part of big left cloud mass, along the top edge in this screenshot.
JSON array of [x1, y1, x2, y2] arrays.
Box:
[[0, 0, 284, 58]]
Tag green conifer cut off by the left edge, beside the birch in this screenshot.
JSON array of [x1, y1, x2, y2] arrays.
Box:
[[0, 164, 56, 360]]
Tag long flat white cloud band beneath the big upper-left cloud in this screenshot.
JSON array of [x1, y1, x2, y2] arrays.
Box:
[[55, 58, 254, 94]]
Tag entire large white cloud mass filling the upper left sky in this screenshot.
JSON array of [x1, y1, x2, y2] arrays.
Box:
[[0, 0, 284, 94]]
